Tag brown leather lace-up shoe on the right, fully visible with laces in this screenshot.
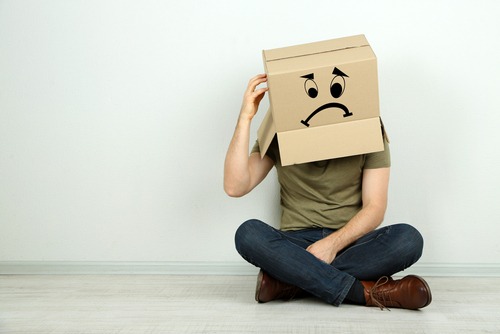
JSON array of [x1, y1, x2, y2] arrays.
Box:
[[361, 275, 432, 310]]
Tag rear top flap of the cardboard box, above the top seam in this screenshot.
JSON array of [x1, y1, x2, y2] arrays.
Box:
[[263, 35, 369, 62]]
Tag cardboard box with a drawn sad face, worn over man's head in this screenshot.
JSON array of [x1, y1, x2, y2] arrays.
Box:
[[257, 35, 384, 166]]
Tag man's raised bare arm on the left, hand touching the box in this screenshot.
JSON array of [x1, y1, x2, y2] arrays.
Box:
[[224, 74, 274, 197]]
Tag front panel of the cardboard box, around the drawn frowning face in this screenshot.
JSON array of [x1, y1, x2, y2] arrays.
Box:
[[268, 54, 379, 132]]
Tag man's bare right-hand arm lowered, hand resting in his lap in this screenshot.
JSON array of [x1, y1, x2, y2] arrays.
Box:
[[307, 167, 390, 263]]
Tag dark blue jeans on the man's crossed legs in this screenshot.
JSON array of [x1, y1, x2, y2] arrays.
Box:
[[235, 219, 423, 306]]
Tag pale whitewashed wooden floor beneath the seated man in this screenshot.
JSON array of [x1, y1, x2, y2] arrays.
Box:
[[0, 275, 500, 334]]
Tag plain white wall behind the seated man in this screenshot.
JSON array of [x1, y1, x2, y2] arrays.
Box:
[[0, 0, 500, 265]]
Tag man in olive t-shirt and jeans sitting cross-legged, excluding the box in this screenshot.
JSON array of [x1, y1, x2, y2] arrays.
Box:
[[224, 74, 432, 309]]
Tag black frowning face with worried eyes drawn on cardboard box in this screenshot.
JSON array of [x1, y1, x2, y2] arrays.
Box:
[[300, 67, 353, 127]]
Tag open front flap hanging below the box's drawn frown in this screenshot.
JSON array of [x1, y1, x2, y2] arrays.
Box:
[[278, 117, 384, 166]]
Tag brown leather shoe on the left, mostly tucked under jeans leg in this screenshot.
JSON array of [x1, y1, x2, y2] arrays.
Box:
[[255, 270, 305, 303]]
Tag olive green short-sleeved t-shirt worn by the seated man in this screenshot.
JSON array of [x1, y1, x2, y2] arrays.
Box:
[[252, 137, 391, 231]]
